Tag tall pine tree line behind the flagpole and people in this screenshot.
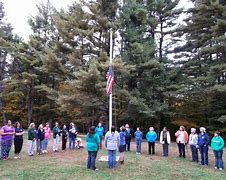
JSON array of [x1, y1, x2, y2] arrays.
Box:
[[0, 0, 226, 137]]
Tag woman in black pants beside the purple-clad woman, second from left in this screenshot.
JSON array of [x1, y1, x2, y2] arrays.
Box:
[[14, 122, 24, 159]]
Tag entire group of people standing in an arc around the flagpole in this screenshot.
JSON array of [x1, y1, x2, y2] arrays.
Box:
[[0, 120, 224, 170]]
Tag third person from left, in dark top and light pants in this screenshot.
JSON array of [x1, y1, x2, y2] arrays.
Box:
[[28, 123, 37, 156]]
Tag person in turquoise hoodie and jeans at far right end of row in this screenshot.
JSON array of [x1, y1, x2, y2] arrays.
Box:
[[211, 131, 224, 170]]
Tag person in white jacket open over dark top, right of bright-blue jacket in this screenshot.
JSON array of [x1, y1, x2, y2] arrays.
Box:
[[160, 127, 171, 157]]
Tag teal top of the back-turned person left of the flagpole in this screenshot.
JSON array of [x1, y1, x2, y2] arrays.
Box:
[[86, 133, 100, 151]]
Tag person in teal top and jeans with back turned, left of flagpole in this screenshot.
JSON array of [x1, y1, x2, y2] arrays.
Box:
[[86, 126, 100, 170]]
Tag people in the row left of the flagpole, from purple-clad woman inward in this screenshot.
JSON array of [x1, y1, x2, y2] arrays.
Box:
[[0, 120, 83, 160]]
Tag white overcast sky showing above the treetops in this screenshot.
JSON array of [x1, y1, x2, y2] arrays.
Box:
[[0, 0, 193, 40]]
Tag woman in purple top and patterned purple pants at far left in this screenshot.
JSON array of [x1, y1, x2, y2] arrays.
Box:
[[0, 120, 15, 160]]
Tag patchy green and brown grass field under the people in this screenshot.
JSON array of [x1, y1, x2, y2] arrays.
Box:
[[0, 136, 226, 180]]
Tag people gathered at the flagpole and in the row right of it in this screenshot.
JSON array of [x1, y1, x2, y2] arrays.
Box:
[[86, 124, 224, 170]]
